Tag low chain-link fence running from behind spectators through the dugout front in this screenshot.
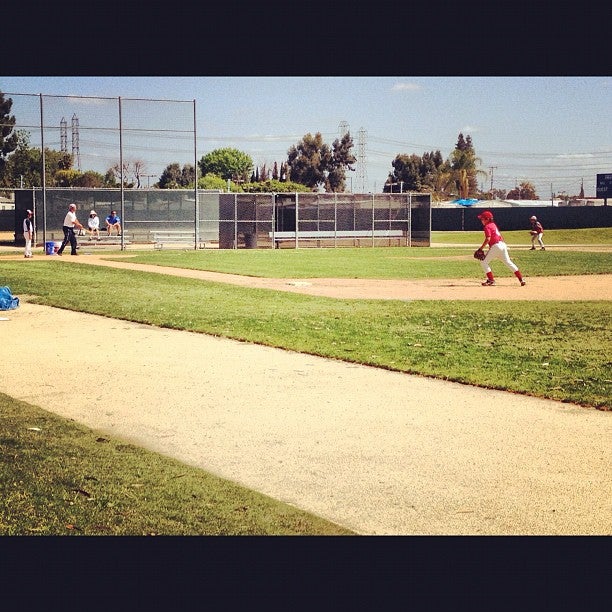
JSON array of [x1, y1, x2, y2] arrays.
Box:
[[9, 188, 431, 249]]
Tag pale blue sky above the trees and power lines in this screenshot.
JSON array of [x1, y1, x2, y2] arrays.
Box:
[[0, 76, 612, 199]]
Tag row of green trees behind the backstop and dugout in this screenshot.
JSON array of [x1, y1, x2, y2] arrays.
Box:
[[0, 91, 537, 200]]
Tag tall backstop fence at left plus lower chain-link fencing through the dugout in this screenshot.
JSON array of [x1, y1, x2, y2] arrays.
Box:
[[4, 92, 431, 249]]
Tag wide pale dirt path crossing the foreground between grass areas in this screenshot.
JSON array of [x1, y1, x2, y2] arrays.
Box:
[[0, 251, 612, 535]]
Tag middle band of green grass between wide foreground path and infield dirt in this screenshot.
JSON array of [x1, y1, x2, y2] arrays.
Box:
[[3, 251, 612, 408]]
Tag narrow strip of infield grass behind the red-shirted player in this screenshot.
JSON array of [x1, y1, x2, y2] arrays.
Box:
[[109, 242, 612, 279]]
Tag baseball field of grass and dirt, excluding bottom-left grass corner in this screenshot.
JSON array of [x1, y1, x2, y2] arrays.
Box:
[[0, 229, 612, 534]]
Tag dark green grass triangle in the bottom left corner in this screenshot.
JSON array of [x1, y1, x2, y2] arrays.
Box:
[[0, 394, 352, 536]]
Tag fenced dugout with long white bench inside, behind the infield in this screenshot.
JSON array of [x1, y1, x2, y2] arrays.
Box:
[[219, 193, 431, 249]]
